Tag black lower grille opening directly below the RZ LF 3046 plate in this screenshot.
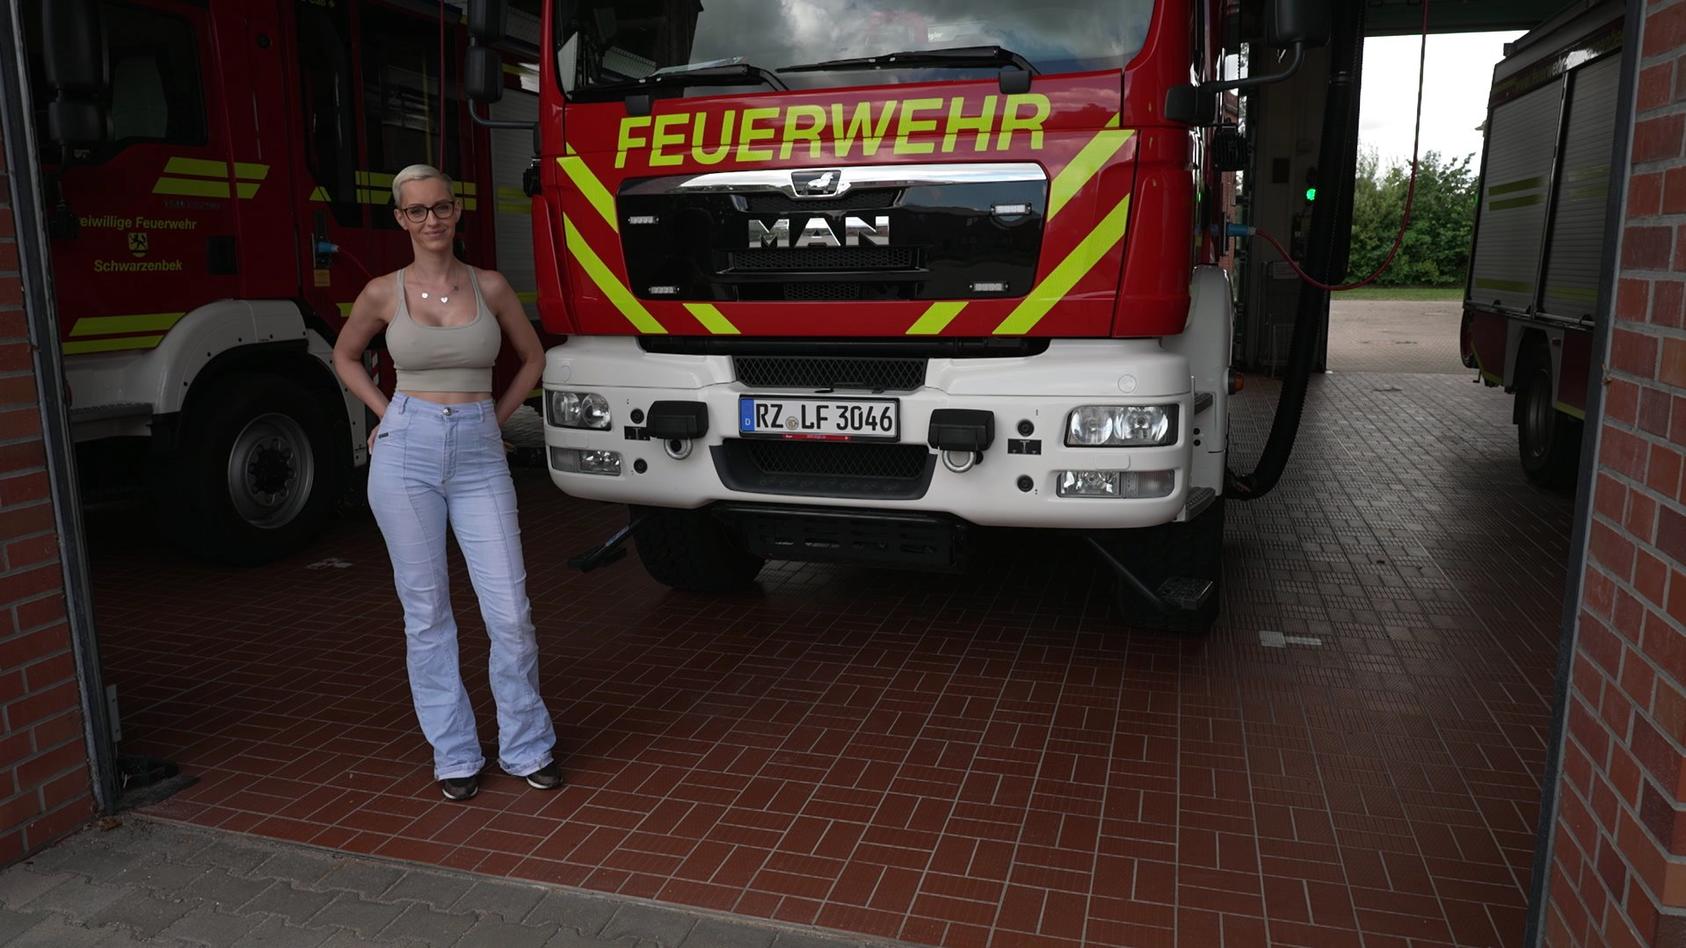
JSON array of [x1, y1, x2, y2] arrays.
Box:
[[710, 439, 936, 501]]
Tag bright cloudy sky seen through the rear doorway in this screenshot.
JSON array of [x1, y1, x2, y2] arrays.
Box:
[[1359, 32, 1522, 167]]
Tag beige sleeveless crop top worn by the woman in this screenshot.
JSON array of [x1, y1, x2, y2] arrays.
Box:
[[386, 267, 504, 391]]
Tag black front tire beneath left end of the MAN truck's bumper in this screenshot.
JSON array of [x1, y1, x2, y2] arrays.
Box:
[[632, 508, 767, 592]]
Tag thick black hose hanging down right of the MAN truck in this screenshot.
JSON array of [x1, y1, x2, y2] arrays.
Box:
[[1224, 2, 1366, 501]]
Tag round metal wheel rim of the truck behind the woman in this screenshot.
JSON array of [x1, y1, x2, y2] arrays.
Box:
[[228, 412, 315, 530]]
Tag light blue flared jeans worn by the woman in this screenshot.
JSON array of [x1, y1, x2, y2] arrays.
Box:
[[369, 393, 556, 779]]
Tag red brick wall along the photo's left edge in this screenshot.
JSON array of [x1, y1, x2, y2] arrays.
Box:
[[0, 116, 94, 865]]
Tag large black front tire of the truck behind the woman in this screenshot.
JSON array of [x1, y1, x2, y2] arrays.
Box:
[[155, 373, 349, 567]]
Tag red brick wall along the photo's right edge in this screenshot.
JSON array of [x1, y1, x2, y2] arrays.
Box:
[[1544, 0, 1686, 946]]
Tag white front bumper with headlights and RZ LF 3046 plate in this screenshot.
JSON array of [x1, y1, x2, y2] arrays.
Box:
[[543, 337, 1224, 530]]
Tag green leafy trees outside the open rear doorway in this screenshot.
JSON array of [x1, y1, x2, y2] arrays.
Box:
[[1347, 150, 1477, 287]]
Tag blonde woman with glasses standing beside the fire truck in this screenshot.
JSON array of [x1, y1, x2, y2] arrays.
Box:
[[334, 165, 561, 800]]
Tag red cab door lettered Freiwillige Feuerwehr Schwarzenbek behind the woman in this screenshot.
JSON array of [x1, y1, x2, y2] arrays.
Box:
[[54, 0, 242, 347]]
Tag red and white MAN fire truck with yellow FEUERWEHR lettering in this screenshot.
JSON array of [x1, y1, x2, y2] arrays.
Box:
[[467, 0, 1317, 622]]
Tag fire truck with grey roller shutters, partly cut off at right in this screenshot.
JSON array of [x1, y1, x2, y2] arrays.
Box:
[[1460, 0, 1624, 486]]
